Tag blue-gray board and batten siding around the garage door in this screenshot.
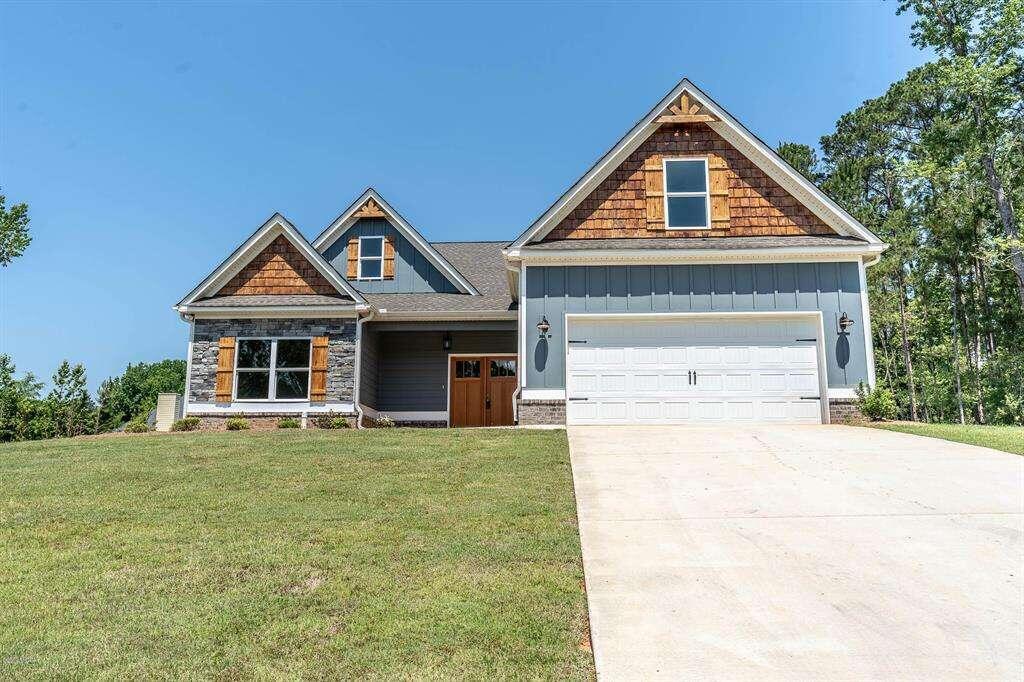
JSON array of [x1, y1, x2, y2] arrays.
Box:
[[523, 262, 868, 389]]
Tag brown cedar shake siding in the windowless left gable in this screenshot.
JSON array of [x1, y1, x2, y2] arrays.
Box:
[[217, 235, 338, 296]]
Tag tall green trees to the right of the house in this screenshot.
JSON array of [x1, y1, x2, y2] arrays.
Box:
[[778, 0, 1024, 424]]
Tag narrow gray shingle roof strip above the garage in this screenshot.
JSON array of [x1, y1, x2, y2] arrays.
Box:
[[521, 235, 867, 251]]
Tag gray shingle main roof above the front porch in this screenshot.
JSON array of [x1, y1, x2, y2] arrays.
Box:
[[364, 242, 516, 313]]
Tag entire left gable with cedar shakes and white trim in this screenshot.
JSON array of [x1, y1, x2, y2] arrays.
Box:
[[177, 213, 366, 309]]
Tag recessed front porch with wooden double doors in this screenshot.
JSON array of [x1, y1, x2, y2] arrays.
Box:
[[358, 321, 519, 426]]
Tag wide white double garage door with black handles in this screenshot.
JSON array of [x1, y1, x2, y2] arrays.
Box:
[[565, 316, 821, 424]]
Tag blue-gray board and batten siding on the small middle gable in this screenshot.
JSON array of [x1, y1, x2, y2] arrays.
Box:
[[324, 218, 459, 294]]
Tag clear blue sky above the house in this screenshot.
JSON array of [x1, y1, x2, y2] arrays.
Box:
[[0, 2, 925, 388]]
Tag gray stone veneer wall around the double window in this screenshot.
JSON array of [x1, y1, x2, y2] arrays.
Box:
[[188, 317, 355, 405]]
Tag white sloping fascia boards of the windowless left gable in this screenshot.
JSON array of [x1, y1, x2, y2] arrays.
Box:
[[176, 213, 366, 309]]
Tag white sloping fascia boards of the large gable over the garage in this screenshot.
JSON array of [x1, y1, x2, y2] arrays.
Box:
[[510, 78, 882, 248]]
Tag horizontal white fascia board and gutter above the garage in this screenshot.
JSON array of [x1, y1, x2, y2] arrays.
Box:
[[508, 244, 887, 265]]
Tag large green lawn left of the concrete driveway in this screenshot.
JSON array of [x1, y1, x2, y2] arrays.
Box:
[[0, 429, 594, 679]]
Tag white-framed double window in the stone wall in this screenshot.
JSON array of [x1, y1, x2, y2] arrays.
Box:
[[234, 339, 310, 400]]
